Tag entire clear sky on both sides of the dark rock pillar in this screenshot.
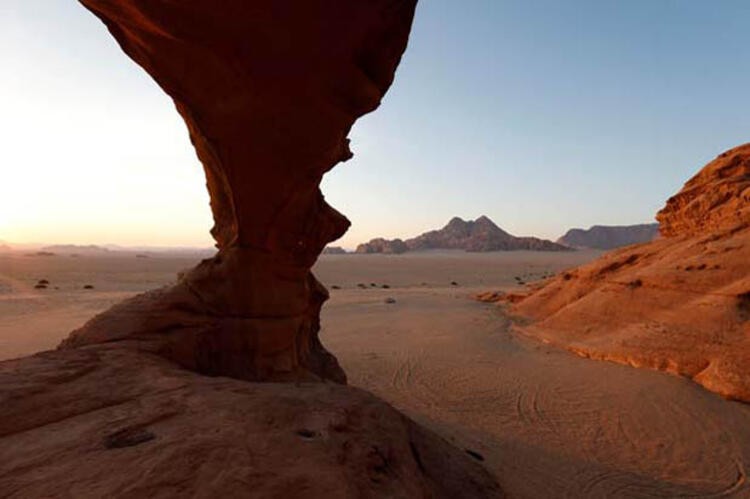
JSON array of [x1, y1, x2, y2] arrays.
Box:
[[0, 0, 750, 248]]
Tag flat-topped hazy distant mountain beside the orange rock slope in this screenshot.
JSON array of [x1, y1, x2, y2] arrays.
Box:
[[557, 223, 659, 250]]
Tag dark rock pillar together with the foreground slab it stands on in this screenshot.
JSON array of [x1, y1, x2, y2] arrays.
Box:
[[0, 0, 502, 498]]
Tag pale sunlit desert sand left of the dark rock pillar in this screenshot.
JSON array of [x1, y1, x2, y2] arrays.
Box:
[[0, 251, 198, 360]]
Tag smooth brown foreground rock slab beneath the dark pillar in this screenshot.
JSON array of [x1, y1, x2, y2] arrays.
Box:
[[0, 345, 502, 499]]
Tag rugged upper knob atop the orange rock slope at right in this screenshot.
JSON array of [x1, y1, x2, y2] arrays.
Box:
[[656, 144, 750, 237]]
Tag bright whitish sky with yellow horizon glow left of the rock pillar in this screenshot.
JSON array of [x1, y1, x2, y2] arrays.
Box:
[[0, 1, 213, 246]]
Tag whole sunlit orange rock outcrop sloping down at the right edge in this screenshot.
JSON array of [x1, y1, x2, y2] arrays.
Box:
[[496, 144, 750, 402]]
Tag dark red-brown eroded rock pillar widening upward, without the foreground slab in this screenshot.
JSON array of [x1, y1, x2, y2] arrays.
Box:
[[62, 0, 416, 382]]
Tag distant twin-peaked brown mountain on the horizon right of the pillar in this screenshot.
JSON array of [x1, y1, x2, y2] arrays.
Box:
[[357, 216, 570, 253]]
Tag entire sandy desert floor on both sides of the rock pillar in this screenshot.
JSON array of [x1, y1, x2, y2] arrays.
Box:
[[0, 252, 750, 498]]
